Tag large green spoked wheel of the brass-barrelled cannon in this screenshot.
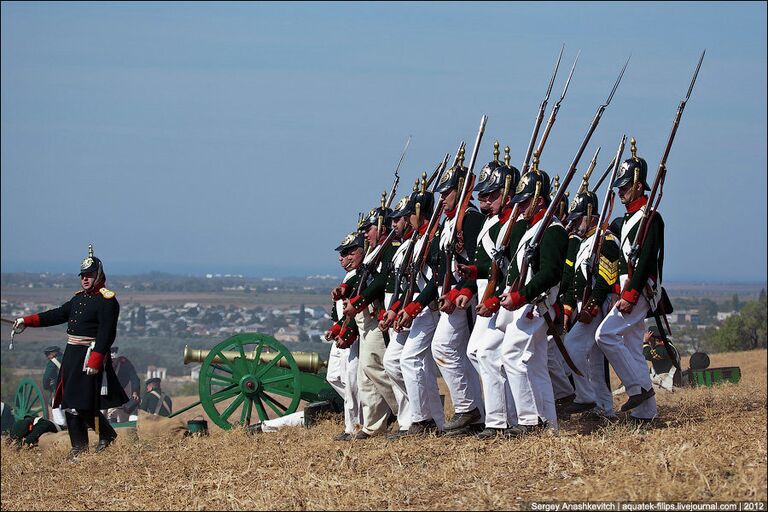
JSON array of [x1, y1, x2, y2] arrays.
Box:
[[199, 333, 301, 430]]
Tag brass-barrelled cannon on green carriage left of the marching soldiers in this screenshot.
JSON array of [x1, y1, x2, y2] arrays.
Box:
[[171, 333, 343, 430]]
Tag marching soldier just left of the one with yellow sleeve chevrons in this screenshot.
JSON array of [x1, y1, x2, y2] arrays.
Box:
[[496, 156, 568, 436]]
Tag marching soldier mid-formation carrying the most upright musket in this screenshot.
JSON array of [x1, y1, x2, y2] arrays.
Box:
[[400, 152, 484, 435]]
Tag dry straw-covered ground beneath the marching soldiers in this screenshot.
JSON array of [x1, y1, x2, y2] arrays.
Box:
[[1, 350, 766, 510]]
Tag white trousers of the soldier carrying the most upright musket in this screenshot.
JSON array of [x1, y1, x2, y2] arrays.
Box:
[[432, 297, 485, 421]]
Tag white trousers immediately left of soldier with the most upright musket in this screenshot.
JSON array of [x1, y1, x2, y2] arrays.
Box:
[[400, 308, 445, 430]]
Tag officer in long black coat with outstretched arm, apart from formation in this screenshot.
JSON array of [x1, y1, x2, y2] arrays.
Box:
[[13, 245, 128, 458]]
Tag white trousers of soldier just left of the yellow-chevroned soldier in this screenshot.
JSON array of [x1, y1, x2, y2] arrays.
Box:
[[501, 304, 557, 429]]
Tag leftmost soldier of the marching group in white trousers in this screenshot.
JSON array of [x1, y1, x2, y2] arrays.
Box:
[[325, 232, 365, 441]]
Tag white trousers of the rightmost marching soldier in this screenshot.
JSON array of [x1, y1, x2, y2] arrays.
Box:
[[595, 276, 658, 419]]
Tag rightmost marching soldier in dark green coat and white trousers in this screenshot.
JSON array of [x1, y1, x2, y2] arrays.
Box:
[[596, 139, 664, 424]]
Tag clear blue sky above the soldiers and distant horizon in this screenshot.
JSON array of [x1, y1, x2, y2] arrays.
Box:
[[0, 2, 767, 281]]
